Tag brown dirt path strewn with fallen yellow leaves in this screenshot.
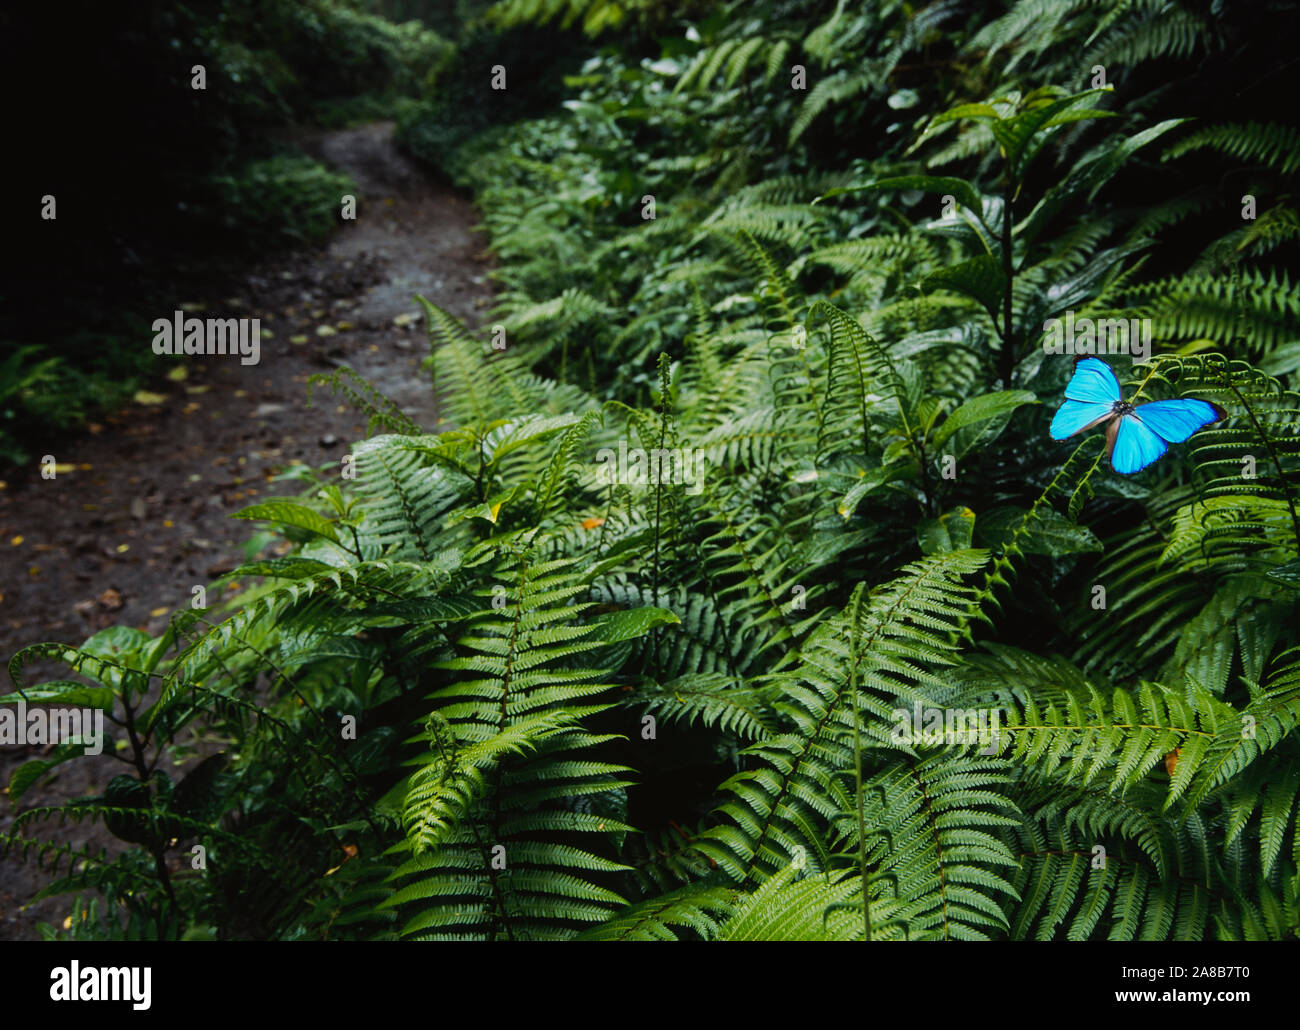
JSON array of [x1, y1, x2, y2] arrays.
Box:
[[0, 122, 491, 939]]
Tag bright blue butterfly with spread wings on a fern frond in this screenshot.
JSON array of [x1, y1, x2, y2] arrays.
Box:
[[1050, 358, 1225, 476]]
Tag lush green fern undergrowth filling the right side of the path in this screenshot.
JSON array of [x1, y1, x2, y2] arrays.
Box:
[[5, 0, 1300, 940]]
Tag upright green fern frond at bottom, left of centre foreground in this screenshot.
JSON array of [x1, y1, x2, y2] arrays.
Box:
[[384, 553, 673, 939]]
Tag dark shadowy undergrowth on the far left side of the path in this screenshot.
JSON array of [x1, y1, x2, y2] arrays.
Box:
[[0, 0, 454, 469]]
